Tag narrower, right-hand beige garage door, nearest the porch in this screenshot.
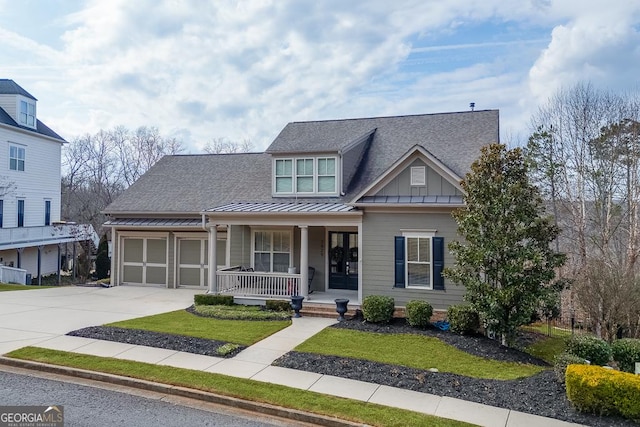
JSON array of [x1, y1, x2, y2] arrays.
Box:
[[178, 239, 208, 287]]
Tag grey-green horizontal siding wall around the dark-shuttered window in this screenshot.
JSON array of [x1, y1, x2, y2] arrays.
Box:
[[362, 212, 465, 310]]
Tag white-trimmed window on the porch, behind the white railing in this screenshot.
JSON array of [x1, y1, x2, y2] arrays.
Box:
[[253, 230, 291, 273]]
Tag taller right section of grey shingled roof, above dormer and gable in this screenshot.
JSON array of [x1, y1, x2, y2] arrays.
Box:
[[266, 110, 500, 193]]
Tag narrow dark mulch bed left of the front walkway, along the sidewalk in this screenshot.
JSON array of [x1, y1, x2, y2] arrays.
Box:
[[67, 326, 247, 358]]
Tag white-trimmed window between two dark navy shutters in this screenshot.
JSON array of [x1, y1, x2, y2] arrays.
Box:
[[403, 232, 434, 289]]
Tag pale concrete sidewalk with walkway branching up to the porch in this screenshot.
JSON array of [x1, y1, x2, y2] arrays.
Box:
[[22, 317, 577, 427]]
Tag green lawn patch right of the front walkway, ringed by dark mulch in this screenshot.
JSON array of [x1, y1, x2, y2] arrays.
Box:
[[295, 328, 544, 380]]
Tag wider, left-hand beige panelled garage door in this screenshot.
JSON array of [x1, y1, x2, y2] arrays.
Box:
[[122, 237, 167, 286]]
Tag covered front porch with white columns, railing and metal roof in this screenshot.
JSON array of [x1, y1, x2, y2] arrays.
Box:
[[202, 203, 362, 304]]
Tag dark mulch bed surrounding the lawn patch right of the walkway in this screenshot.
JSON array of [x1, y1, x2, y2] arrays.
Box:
[[274, 319, 637, 426]]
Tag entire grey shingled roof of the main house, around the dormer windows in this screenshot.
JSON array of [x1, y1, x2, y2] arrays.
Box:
[[105, 110, 499, 215]]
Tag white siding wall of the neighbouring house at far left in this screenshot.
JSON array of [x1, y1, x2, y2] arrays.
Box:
[[0, 127, 62, 228]]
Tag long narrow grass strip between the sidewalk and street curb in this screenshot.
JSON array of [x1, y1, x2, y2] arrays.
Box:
[[7, 347, 471, 427]]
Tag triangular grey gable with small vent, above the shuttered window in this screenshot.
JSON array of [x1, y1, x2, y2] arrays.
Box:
[[371, 159, 462, 196]]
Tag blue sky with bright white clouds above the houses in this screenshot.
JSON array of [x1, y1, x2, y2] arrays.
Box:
[[0, 0, 640, 154]]
